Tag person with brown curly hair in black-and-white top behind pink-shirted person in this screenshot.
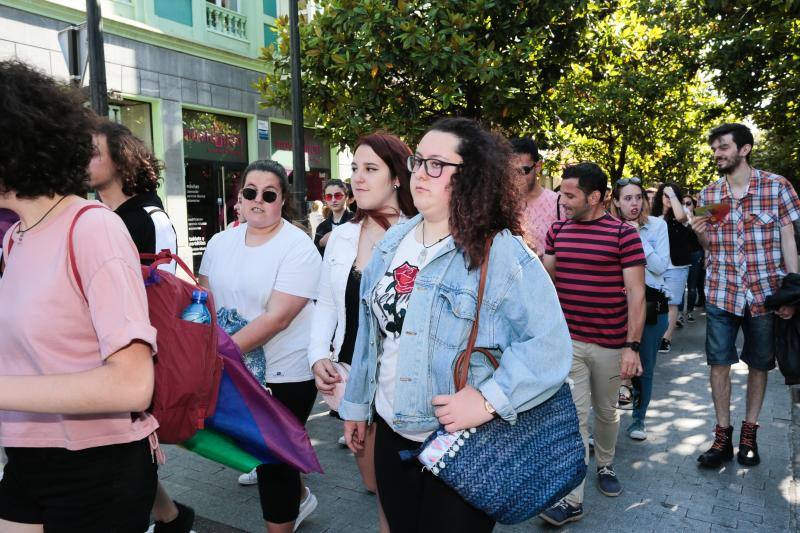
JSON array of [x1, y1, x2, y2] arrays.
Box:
[[89, 119, 178, 273]]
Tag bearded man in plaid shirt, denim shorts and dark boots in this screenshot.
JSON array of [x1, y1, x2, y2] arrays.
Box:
[[692, 124, 800, 468]]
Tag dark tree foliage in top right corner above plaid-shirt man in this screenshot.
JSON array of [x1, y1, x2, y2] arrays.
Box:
[[703, 0, 800, 186]]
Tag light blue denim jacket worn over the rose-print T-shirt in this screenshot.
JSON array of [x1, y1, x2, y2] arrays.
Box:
[[339, 215, 572, 431]]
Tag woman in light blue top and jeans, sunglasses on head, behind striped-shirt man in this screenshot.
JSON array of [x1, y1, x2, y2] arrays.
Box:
[[611, 178, 670, 440]]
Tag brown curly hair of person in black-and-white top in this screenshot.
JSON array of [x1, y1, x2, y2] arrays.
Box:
[[95, 118, 164, 196]]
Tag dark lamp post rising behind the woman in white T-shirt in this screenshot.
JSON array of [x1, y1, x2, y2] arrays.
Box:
[[289, 0, 306, 220]]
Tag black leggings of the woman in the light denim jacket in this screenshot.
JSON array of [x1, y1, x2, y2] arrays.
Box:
[[375, 417, 494, 533]]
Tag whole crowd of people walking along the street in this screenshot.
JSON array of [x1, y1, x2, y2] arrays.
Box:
[[0, 61, 800, 533]]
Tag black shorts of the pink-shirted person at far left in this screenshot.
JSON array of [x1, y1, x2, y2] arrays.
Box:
[[0, 439, 158, 533]]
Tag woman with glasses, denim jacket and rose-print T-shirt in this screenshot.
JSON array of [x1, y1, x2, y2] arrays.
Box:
[[339, 118, 571, 532]]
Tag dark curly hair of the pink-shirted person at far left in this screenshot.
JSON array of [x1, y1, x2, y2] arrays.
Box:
[[0, 61, 92, 199]]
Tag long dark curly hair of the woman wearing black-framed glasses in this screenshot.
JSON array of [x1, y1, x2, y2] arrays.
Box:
[[430, 118, 526, 268]]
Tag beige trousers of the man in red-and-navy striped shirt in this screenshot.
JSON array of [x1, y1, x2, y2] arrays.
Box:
[[566, 340, 622, 505]]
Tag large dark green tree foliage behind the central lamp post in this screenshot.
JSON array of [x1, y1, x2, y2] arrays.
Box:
[[259, 0, 588, 145]]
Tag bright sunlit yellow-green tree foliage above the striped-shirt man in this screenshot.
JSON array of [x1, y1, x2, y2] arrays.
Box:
[[546, 0, 722, 188]]
